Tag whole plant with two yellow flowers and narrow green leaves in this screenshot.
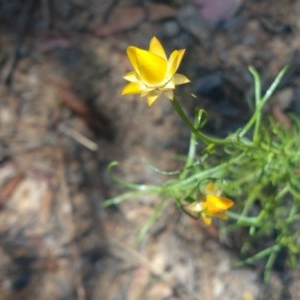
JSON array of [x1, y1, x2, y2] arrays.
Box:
[[104, 37, 300, 274]]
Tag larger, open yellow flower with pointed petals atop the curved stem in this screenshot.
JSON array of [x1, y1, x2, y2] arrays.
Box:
[[122, 37, 189, 106]]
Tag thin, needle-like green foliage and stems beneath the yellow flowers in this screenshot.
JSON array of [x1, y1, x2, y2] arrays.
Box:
[[105, 68, 300, 279]]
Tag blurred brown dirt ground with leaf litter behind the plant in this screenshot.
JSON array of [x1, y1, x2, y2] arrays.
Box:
[[0, 0, 300, 300]]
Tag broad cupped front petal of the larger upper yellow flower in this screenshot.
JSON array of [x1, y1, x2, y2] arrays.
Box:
[[127, 47, 168, 87]]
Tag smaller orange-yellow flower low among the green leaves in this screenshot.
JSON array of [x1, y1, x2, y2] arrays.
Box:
[[183, 182, 234, 225]]
